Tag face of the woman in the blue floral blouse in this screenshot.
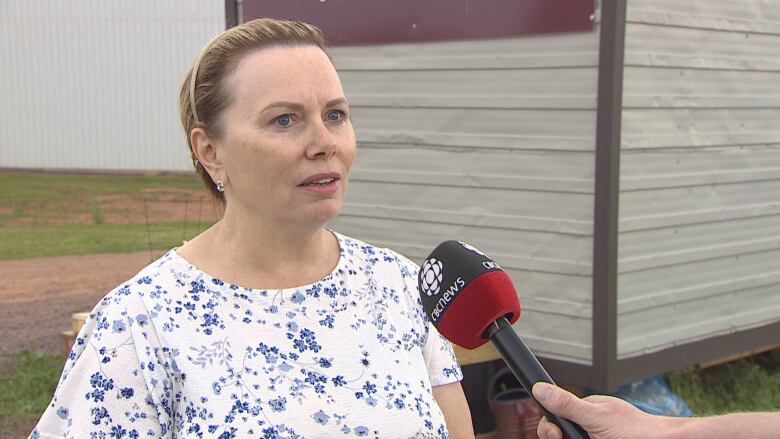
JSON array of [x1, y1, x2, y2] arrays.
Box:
[[215, 46, 355, 226]]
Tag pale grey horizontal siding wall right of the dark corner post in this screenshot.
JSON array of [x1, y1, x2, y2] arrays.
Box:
[[618, 0, 780, 358]]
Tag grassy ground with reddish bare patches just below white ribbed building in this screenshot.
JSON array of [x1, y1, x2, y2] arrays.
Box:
[[0, 172, 212, 260]]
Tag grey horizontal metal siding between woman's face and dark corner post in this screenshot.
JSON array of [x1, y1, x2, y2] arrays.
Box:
[[326, 24, 598, 364]]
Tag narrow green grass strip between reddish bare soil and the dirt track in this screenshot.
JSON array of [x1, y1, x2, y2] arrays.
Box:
[[0, 221, 210, 260]]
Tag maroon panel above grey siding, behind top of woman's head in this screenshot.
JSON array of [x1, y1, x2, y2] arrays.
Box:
[[243, 0, 594, 45]]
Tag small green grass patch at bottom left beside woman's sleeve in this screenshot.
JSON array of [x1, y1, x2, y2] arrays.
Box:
[[0, 350, 65, 416]]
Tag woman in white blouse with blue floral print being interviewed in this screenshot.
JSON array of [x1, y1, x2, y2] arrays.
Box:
[[31, 19, 473, 438]]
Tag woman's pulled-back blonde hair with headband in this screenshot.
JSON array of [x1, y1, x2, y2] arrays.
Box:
[[179, 18, 328, 203]]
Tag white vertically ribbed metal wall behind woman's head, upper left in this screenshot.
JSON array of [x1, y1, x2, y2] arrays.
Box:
[[0, 0, 225, 170]]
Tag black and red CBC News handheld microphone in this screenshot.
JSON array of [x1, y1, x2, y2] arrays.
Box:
[[418, 241, 590, 439]]
